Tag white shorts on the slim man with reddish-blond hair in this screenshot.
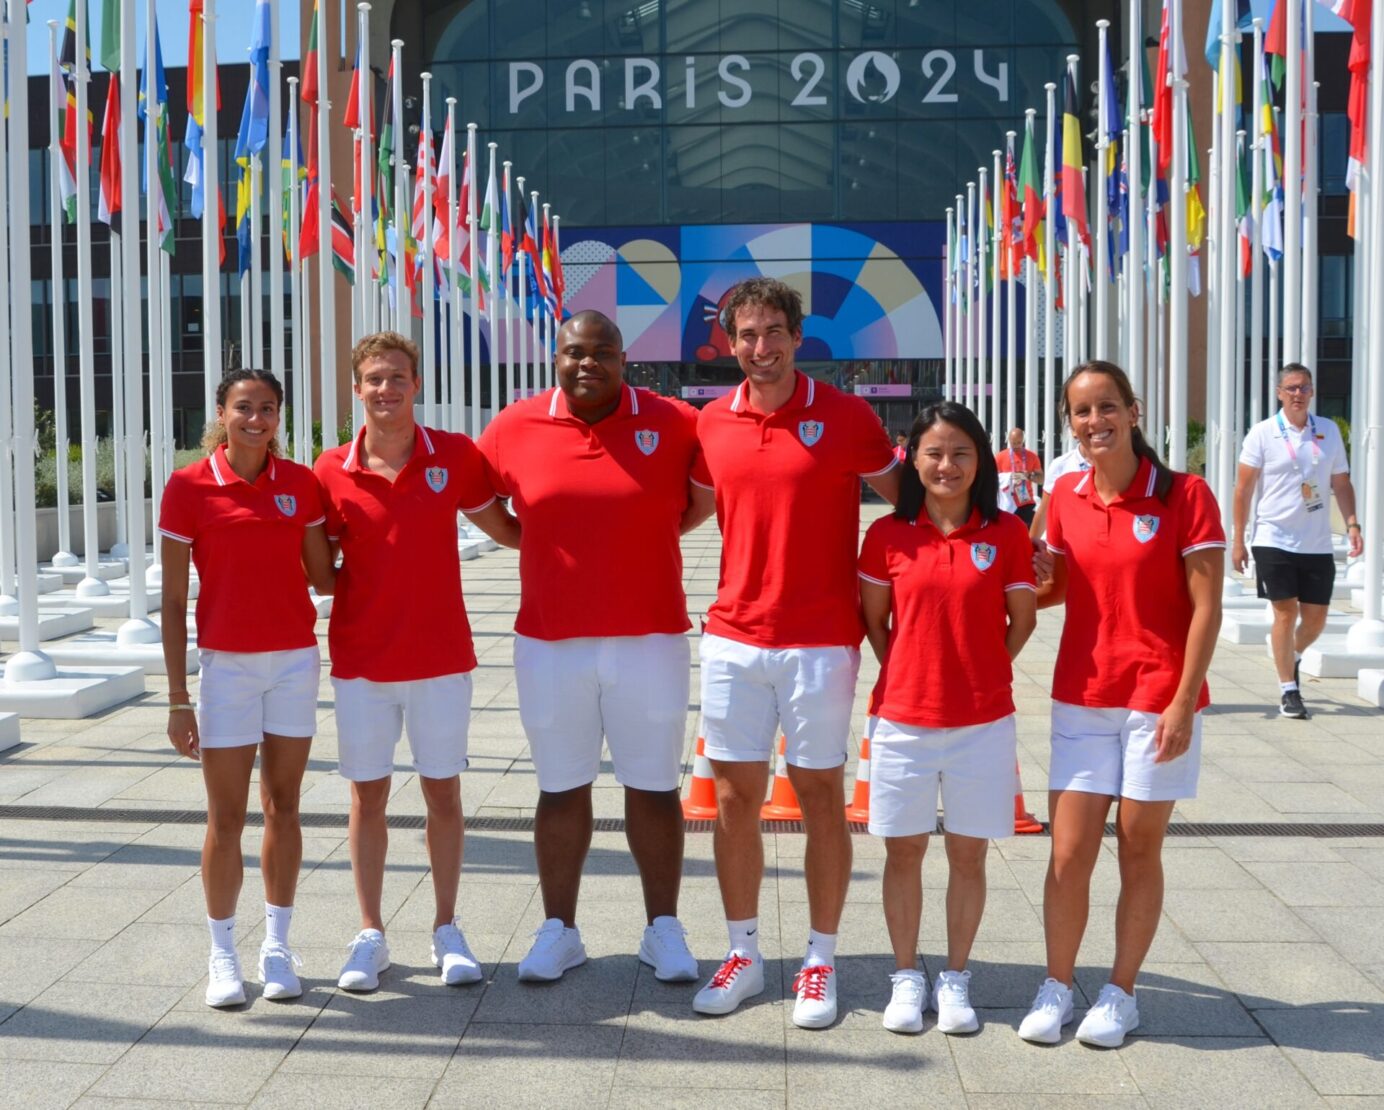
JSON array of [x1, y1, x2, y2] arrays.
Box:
[[332, 671, 471, 782]]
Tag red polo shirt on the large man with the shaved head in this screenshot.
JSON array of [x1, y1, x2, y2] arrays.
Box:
[[479, 386, 698, 639]]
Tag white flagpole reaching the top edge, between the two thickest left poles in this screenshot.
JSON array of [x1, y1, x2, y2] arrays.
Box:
[[73, 4, 105, 598]]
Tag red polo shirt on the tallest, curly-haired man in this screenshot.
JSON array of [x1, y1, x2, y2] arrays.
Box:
[[692, 372, 898, 648]]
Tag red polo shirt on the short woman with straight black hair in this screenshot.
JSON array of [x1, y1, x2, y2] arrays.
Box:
[[859, 511, 1035, 728]]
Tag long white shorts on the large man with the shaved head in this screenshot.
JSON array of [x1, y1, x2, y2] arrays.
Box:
[[515, 634, 692, 793]]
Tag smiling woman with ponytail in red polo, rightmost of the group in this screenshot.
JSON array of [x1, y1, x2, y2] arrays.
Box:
[[1019, 361, 1225, 1048]]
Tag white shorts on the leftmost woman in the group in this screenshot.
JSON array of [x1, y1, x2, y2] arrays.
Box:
[[197, 648, 322, 747]]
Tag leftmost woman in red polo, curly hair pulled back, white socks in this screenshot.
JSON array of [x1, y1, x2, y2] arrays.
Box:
[[159, 370, 335, 1006]]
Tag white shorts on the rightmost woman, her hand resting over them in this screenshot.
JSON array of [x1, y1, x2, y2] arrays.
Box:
[[1048, 702, 1201, 801]]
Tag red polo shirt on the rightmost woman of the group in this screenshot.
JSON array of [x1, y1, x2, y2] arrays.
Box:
[[1048, 460, 1225, 713]]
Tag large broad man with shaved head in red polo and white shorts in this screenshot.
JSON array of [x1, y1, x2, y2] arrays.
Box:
[[480, 311, 710, 981]]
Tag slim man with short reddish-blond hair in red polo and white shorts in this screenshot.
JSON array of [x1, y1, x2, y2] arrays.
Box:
[[313, 332, 519, 991]]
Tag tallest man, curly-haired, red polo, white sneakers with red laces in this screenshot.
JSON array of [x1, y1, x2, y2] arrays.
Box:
[[692, 278, 898, 1028]]
